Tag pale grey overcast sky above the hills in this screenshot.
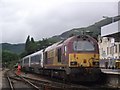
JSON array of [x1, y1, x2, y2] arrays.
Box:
[[0, 0, 119, 44]]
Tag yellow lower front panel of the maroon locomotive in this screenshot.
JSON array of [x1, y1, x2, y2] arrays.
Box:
[[69, 53, 98, 67]]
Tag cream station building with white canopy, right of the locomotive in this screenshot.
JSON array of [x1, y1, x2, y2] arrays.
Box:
[[98, 15, 120, 68]]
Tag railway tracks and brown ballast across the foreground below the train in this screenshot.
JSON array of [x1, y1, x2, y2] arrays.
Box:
[[4, 71, 118, 90]]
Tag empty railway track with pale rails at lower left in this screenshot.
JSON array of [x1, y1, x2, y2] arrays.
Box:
[[6, 71, 41, 90]]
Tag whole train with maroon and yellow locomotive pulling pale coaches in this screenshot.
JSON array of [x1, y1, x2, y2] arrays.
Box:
[[20, 35, 101, 82]]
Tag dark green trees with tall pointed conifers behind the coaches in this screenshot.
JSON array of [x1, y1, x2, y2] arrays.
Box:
[[20, 36, 56, 58]]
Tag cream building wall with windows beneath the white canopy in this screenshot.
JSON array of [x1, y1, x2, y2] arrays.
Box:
[[99, 37, 120, 59]]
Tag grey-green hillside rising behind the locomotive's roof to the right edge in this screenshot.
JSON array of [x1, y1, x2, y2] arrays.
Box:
[[50, 15, 120, 41]]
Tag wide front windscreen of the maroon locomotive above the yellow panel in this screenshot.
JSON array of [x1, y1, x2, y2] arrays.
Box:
[[73, 41, 95, 51]]
